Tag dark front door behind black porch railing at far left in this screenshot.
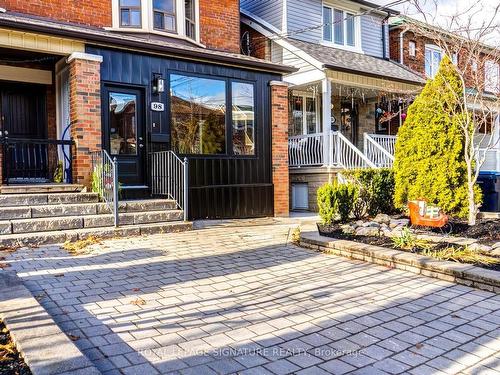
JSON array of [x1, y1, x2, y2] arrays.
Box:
[[0, 83, 49, 182]]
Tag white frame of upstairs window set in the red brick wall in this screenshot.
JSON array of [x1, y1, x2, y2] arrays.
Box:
[[110, 0, 202, 45]]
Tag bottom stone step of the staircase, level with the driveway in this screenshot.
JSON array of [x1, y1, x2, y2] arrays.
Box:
[[0, 221, 193, 250]]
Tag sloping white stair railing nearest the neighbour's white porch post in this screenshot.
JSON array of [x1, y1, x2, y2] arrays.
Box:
[[330, 131, 376, 169]]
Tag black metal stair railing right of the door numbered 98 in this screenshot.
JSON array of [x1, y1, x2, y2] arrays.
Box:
[[151, 151, 188, 221]]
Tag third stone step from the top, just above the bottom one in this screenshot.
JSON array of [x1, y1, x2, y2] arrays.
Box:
[[0, 210, 183, 235]]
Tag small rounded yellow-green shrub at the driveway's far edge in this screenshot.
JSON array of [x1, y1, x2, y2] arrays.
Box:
[[318, 182, 359, 224]]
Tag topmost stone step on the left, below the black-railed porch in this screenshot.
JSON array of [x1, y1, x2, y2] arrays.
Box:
[[0, 193, 99, 207]]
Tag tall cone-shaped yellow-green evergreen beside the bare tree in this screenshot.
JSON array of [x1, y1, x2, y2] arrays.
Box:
[[394, 57, 480, 217]]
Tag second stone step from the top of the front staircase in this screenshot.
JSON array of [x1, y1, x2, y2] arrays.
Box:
[[0, 199, 176, 220]]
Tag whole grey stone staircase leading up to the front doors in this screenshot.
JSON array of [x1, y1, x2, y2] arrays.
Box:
[[0, 192, 192, 249]]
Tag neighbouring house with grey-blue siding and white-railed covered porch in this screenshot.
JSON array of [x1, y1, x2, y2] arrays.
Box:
[[241, 0, 425, 210]]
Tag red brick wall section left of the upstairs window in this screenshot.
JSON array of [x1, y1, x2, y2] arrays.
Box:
[[0, 0, 111, 27]]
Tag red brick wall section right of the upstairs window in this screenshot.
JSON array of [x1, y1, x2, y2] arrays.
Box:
[[199, 0, 240, 53]]
